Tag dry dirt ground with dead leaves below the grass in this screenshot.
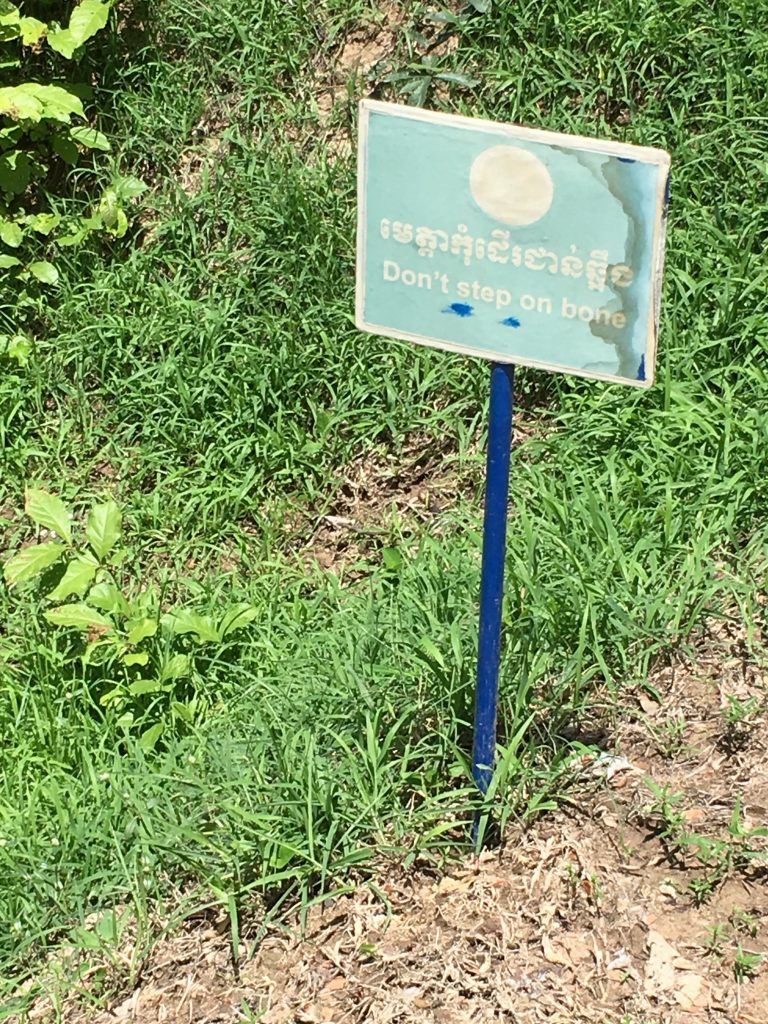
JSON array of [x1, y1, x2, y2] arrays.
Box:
[[20, 626, 768, 1024]]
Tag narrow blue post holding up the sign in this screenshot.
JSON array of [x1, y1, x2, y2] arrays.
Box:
[[472, 364, 515, 795]]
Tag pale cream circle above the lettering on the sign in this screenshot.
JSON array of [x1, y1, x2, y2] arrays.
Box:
[[469, 145, 554, 227]]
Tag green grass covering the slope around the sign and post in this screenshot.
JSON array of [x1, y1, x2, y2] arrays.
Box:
[[0, 0, 768, 1011]]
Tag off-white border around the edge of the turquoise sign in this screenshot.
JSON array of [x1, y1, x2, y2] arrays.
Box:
[[354, 99, 672, 388]]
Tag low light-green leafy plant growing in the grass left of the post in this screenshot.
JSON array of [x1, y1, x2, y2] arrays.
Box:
[[3, 488, 257, 751]]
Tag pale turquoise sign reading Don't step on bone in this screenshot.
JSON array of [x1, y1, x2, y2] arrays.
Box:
[[356, 100, 670, 387]]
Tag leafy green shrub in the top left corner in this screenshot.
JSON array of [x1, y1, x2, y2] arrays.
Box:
[[0, 0, 144, 364]]
